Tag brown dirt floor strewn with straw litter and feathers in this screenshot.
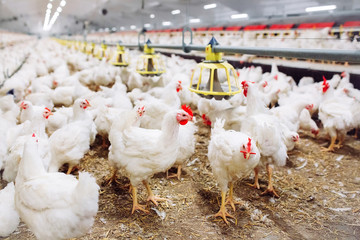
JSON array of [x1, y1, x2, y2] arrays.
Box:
[[1, 111, 360, 240]]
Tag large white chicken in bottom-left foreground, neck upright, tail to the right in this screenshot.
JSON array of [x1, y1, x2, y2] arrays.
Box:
[[15, 134, 99, 239]]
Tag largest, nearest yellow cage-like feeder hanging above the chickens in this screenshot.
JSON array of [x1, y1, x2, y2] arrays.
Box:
[[189, 37, 241, 100]]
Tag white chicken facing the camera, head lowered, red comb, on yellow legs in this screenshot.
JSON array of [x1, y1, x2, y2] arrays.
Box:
[[208, 119, 260, 224]]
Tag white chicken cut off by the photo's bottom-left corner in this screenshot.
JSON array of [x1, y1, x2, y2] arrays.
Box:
[[0, 182, 20, 237]]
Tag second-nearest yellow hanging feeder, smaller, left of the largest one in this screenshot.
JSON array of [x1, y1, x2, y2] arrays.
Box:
[[136, 40, 165, 77]]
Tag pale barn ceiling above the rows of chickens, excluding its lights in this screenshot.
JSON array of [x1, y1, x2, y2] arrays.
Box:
[[0, 0, 360, 35]]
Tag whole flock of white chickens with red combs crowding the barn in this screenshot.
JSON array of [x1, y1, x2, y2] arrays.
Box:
[[0, 40, 360, 239]]
